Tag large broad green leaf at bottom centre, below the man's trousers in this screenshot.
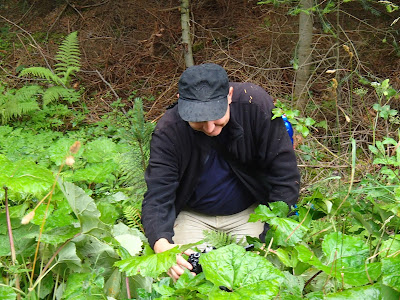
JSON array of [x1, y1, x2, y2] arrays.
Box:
[[200, 244, 283, 299]]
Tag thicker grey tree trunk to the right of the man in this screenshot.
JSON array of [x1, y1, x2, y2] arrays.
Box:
[[294, 0, 313, 109]]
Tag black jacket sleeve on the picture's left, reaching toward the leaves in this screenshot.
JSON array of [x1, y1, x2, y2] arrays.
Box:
[[142, 124, 179, 248]]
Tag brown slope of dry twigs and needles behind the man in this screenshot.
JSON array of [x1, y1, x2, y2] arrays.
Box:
[[0, 0, 400, 190]]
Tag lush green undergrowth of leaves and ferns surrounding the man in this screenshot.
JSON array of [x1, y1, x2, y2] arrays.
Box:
[[0, 19, 400, 300]]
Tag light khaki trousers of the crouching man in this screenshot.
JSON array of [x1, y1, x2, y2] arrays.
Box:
[[172, 204, 264, 249]]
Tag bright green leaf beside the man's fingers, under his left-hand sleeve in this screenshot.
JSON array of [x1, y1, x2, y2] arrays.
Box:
[[115, 247, 181, 278]]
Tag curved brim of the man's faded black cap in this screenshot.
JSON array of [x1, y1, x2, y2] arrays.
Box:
[[178, 96, 228, 122]]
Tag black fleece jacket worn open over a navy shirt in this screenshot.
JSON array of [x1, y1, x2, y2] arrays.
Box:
[[142, 83, 300, 247]]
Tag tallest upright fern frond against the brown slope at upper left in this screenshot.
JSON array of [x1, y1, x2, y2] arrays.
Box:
[[55, 31, 81, 78]]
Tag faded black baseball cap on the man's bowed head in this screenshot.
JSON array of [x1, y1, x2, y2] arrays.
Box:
[[178, 64, 229, 122]]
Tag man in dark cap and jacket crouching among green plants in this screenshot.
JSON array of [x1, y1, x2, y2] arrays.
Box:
[[142, 63, 300, 279]]
